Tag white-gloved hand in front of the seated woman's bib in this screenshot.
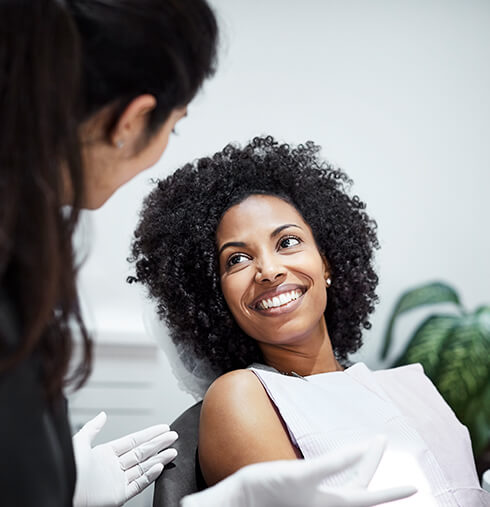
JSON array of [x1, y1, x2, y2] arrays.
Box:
[[181, 437, 417, 507]]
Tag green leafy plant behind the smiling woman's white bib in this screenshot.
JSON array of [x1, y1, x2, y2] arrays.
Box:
[[381, 282, 490, 473]]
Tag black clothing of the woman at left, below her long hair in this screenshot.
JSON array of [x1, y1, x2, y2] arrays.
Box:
[[0, 294, 75, 507]]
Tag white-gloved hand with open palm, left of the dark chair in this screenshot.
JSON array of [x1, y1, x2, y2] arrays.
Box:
[[73, 412, 178, 507]]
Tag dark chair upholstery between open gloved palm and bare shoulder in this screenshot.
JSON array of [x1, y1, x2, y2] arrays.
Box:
[[153, 401, 206, 507]]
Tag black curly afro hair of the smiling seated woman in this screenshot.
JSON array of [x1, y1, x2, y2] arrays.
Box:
[[128, 136, 379, 374]]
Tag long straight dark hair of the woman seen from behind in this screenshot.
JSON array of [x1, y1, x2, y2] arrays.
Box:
[[0, 0, 217, 396]]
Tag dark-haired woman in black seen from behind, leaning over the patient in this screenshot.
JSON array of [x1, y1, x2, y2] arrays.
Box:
[[0, 0, 217, 507]]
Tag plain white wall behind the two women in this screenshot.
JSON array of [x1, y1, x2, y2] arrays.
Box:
[[73, 0, 490, 428]]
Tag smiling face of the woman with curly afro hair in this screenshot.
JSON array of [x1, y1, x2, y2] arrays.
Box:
[[216, 195, 330, 350]]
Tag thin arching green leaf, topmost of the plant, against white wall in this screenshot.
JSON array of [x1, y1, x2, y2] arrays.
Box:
[[381, 282, 461, 359]]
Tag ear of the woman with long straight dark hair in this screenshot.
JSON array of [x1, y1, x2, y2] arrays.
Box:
[[110, 94, 157, 148]]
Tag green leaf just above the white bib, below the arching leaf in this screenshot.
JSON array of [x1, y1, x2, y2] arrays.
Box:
[[394, 315, 460, 381]]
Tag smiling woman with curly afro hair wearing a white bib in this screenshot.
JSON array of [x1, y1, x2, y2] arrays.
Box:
[[133, 137, 489, 506]]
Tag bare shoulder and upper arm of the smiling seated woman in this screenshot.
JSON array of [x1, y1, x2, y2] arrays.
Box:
[[199, 370, 298, 485]]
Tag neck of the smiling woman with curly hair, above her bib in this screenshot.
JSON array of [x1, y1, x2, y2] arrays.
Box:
[[259, 319, 344, 377]]
